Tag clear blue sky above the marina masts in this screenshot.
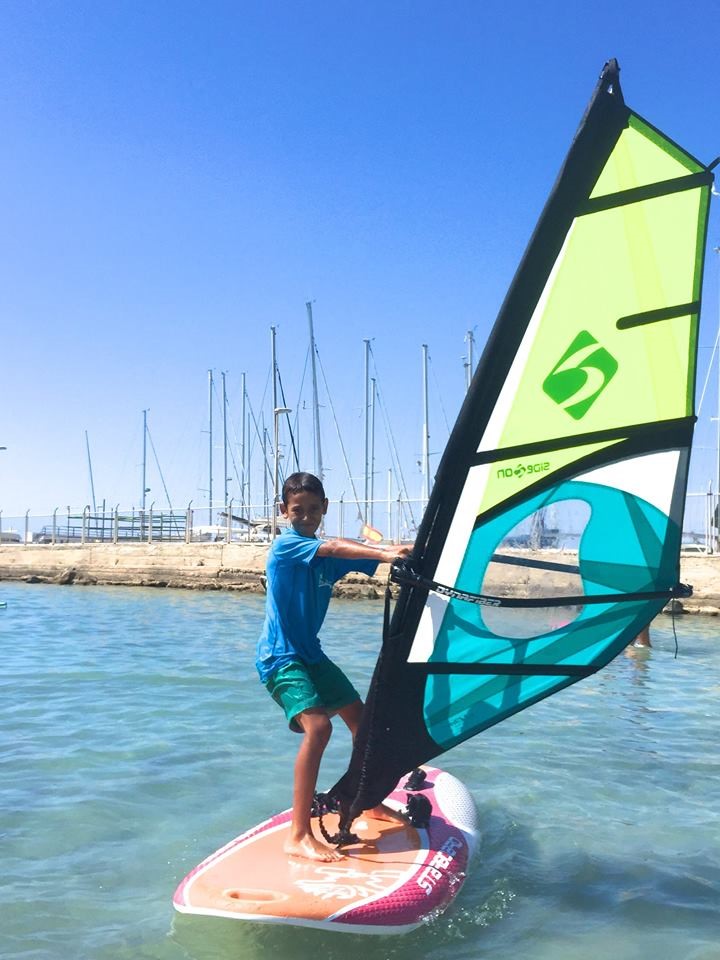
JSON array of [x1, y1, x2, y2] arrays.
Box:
[[0, 0, 720, 518]]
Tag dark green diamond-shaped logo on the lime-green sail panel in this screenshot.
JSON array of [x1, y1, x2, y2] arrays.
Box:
[[543, 330, 618, 420]]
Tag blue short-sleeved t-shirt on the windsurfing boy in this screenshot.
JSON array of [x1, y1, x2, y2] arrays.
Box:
[[256, 527, 377, 683]]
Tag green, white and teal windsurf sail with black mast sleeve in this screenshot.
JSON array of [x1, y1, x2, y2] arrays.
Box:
[[332, 60, 717, 818]]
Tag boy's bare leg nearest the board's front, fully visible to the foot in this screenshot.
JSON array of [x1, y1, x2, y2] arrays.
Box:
[[285, 708, 343, 861]]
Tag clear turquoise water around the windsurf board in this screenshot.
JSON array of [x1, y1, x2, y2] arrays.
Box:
[[0, 584, 720, 960]]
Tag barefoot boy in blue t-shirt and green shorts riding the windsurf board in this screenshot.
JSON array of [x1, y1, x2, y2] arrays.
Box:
[[256, 473, 412, 860]]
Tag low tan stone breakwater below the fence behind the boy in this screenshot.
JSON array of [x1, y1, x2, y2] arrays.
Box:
[[0, 543, 720, 616]]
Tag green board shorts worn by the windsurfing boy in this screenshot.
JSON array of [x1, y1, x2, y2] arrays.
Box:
[[265, 659, 360, 733]]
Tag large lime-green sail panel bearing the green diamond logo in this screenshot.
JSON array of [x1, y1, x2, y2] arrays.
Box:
[[479, 186, 707, 460]]
